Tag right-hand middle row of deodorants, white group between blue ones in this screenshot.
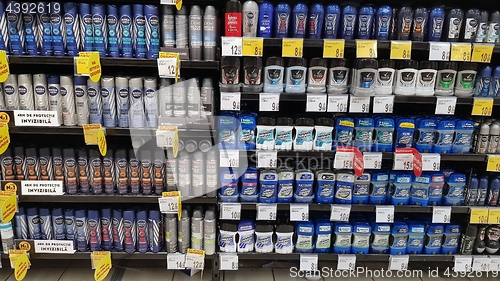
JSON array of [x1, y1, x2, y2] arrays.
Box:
[[217, 112, 472, 153]]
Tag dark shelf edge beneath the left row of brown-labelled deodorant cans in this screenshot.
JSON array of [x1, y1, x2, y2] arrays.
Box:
[[19, 194, 217, 204]]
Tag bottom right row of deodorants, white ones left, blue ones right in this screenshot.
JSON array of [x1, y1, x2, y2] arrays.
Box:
[[219, 215, 460, 255]]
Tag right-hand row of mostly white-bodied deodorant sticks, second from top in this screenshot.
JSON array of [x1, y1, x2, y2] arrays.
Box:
[[220, 57, 484, 97]]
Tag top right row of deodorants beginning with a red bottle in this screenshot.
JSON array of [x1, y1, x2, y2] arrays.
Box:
[[224, 0, 500, 43]]
